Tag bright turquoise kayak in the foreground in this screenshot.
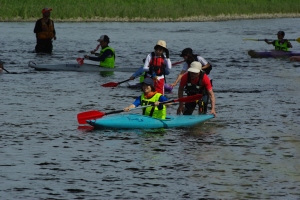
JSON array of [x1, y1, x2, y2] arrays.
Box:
[[87, 114, 214, 129]]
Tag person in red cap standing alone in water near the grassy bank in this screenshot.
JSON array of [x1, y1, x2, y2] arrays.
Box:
[[33, 8, 56, 53]]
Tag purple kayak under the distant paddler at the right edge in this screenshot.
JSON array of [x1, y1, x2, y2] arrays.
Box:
[[248, 50, 300, 58]]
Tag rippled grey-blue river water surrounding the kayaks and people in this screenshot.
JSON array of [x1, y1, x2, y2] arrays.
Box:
[[0, 18, 300, 199]]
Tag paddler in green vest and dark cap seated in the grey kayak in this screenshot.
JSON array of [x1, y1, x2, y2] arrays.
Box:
[[84, 35, 116, 68]]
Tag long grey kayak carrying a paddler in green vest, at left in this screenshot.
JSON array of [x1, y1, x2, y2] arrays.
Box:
[[28, 61, 137, 72]]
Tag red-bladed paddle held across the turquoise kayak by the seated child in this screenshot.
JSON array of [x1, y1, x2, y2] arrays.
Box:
[[77, 94, 202, 124]]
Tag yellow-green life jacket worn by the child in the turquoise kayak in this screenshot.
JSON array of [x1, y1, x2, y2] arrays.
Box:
[[141, 93, 167, 119]]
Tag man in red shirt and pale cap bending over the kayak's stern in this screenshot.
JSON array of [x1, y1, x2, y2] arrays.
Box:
[[177, 61, 216, 117]]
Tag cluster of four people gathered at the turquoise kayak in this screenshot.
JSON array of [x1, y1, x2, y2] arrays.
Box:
[[120, 40, 216, 119]]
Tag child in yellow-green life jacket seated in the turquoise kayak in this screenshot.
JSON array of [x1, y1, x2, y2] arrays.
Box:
[[124, 77, 168, 119]]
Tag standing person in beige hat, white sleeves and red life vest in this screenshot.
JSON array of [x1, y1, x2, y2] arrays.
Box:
[[143, 40, 172, 95]]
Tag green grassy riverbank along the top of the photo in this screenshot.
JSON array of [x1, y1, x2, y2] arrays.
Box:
[[0, 0, 300, 21]]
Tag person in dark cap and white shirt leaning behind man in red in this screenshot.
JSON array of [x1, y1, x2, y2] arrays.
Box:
[[170, 48, 212, 87]]
